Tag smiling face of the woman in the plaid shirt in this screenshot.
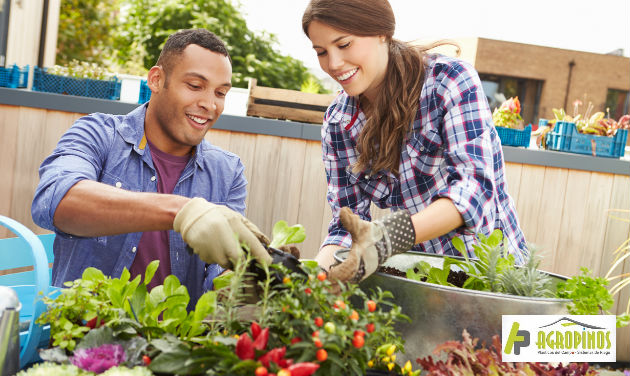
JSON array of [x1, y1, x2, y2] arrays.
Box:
[[308, 21, 388, 102]]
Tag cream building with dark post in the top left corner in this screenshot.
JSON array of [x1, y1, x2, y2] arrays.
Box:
[[0, 0, 61, 67]]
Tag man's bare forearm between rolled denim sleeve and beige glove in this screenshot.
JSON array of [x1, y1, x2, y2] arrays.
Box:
[[53, 180, 190, 236]]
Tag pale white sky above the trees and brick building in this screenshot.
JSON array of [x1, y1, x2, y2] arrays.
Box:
[[233, 0, 630, 71]]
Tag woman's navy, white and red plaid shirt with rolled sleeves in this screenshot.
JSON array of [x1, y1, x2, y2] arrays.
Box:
[[322, 55, 526, 263]]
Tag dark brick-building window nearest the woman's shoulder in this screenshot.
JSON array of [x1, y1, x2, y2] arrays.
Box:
[[479, 74, 543, 124]]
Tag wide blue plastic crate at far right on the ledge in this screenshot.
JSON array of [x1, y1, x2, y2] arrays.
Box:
[[546, 121, 628, 158]]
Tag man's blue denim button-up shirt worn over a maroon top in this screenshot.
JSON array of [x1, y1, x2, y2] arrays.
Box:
[[31, 105, 247, 304]]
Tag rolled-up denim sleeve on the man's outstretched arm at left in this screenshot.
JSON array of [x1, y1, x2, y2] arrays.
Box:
[[31, 114, 113, 234]]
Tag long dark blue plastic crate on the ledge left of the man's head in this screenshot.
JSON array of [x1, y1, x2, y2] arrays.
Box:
[[33, 67, 121, 100]]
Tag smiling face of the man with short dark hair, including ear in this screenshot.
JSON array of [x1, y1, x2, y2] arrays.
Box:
[[145, 44, 232, 155]]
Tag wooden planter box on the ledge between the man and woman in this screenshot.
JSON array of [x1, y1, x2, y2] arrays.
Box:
[[247, 79, 336, 124]]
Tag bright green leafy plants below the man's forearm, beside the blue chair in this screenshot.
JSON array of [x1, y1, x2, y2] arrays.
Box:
[[37, 260, 216, 351]]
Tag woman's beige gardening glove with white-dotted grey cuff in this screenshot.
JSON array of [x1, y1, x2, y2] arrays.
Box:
[[328, 207, 416, 283]]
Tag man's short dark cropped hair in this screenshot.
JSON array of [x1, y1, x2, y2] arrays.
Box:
[[156, 29, 232, 77]]
